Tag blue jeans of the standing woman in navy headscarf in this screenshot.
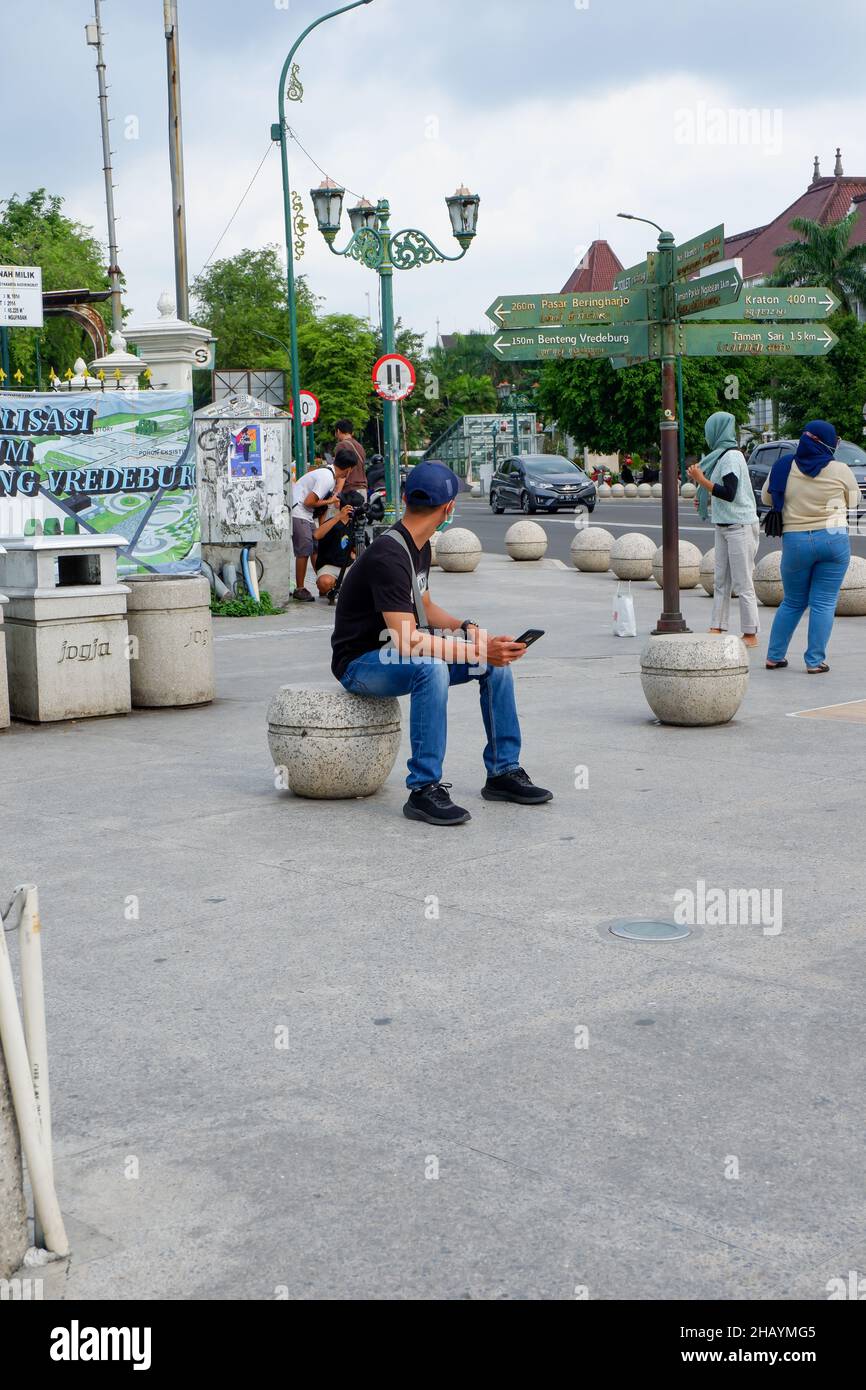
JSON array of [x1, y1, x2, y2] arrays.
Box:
[[767, 527, 851, 666]]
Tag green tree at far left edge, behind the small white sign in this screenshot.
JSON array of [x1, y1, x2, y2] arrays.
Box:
[[0, 188, 111, 386]]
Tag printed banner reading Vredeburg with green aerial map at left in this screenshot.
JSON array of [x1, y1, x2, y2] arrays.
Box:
[[0, 391, 200, 574]]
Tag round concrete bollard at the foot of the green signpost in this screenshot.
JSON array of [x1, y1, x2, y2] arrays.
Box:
[[641, 632, 749, 727]]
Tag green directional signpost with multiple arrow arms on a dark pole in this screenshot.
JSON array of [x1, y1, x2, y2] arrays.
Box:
[[487, 213, 838, 632]]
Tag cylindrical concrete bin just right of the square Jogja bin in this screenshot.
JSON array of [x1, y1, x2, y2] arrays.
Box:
[[126, 575, 215, 709]]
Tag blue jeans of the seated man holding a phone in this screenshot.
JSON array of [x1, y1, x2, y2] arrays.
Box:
[[341, 648, 520, 791]]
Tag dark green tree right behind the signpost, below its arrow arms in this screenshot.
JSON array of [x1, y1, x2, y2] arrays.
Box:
[[538, 357, 766, 453]]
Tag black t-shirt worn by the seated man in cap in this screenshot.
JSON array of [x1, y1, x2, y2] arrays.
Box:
[[331, 523, 432, 680]]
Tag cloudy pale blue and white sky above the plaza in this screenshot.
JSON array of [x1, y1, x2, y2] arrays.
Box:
[[0, 0, 866, 347]]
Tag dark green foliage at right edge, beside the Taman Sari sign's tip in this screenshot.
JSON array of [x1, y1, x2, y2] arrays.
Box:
[[771, 310, 866, 443]]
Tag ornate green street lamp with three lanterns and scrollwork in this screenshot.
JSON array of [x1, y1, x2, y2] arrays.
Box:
[[310, 179, 481, 520]]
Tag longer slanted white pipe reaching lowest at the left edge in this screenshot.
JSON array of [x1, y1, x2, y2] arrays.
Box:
[[0, 889, 70, 1255]]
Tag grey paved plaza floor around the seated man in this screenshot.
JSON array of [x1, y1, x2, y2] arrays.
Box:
[[0, 544, 866, 1300]]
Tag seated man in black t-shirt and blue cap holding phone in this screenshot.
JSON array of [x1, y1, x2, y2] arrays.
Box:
[[331, 461, 553, 826]]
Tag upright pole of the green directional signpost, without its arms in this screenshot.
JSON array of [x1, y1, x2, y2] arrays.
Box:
[[655, 232, 688, 634]]
